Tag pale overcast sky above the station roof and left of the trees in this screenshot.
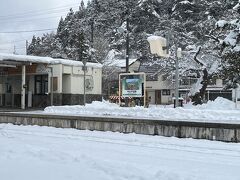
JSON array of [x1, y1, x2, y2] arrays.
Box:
[[0, 0, 87, 54]]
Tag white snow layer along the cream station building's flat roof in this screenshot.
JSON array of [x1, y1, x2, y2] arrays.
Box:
[[0, 53, 102, 68]]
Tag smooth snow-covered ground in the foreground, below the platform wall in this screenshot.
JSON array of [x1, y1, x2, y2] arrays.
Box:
[[0, 124, 240, 180]]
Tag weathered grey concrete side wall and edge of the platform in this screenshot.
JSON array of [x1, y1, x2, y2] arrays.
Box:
[[0, 112, 240, 142]]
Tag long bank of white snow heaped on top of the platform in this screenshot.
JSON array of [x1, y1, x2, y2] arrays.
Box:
[[39, 97, 240, 123]]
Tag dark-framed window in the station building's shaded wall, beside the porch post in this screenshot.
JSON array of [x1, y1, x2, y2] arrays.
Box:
[[35, 75, 48, 94]]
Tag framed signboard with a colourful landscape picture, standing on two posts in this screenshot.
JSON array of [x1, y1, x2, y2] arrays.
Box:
[[119, 73, 146, 107]]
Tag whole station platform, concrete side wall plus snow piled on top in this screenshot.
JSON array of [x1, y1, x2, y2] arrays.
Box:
[[0, 98, 240, 142]]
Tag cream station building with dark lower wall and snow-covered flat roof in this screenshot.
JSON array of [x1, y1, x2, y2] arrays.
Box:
[[0, 53, 102, 109]]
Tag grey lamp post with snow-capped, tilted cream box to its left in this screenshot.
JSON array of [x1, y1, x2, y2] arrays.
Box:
[[147, 36, 182, 107]]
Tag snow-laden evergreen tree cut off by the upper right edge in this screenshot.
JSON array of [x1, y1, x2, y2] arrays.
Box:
[[211, 1, 240, 88]]
